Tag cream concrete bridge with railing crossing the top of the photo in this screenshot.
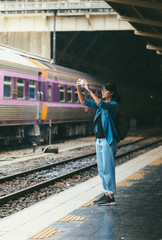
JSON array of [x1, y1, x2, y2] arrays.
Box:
[[0, 0, 132, 32]]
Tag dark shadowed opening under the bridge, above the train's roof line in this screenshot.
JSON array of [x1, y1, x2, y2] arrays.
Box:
[[51, 31, 162, 94]]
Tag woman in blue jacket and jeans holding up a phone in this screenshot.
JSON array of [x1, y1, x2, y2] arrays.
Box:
[[76, 79, 119, 205]]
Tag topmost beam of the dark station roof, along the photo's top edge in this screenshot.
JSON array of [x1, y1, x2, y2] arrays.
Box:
[[106, 0, 162, 10]]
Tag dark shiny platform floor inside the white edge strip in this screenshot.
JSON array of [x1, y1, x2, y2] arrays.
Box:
[[46, 158, 162, 240]]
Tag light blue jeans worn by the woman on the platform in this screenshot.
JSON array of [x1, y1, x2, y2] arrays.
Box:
[[96, 138, 117, 194]]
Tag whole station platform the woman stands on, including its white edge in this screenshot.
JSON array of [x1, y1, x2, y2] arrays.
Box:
[[0, 146, 162, 240]]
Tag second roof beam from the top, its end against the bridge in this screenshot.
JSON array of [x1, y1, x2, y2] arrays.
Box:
[[117, 15, 162, 27]]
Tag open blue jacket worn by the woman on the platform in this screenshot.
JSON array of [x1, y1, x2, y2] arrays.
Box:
[[83, 98, 119, 144]]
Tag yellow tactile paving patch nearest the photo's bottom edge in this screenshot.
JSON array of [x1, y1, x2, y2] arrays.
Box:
[[31, 227, 62, 239]]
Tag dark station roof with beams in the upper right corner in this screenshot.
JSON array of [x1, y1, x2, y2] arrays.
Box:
[[106, 0, 162, 54]]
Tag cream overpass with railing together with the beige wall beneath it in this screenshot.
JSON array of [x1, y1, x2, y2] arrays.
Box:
[[0, 0, 133, 57]]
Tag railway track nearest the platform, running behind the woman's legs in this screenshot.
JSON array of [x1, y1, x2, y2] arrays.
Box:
[[0, 138, 162, 204]]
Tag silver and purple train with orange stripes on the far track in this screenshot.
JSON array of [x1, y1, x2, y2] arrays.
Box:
[[0, 45, 162, 145]]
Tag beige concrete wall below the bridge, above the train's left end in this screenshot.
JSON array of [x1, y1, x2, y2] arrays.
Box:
[[0, 32, 51, 58]]
